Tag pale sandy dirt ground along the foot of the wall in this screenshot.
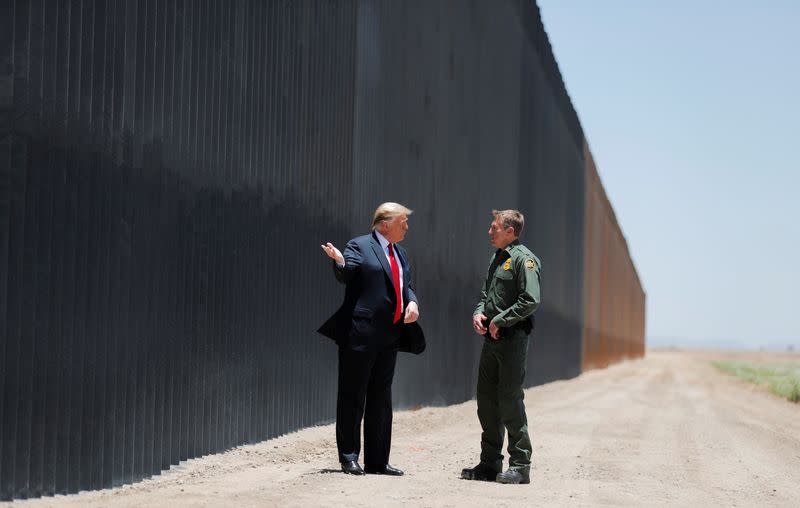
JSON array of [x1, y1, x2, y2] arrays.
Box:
[[7, 351, 800, 507]]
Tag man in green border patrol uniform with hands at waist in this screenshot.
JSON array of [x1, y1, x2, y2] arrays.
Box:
[[461, 210, 541, 483]]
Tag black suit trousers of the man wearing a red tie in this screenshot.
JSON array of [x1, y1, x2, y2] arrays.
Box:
[[336, 347, 397, 466]]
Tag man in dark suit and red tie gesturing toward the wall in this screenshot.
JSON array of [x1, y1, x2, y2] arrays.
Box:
[[318, 203, 425, 476]]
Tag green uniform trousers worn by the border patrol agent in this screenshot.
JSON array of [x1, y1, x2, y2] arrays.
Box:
[[477, 329, 533, 475]]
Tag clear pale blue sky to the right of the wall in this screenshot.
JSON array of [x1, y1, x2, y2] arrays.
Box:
[[538, 0, 800, 347]]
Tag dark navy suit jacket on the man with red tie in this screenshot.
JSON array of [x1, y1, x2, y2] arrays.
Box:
[[317, 233, 425, 354]]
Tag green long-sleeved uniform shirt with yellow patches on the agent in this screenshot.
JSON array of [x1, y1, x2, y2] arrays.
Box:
[[473, 240, 542, 328]]
